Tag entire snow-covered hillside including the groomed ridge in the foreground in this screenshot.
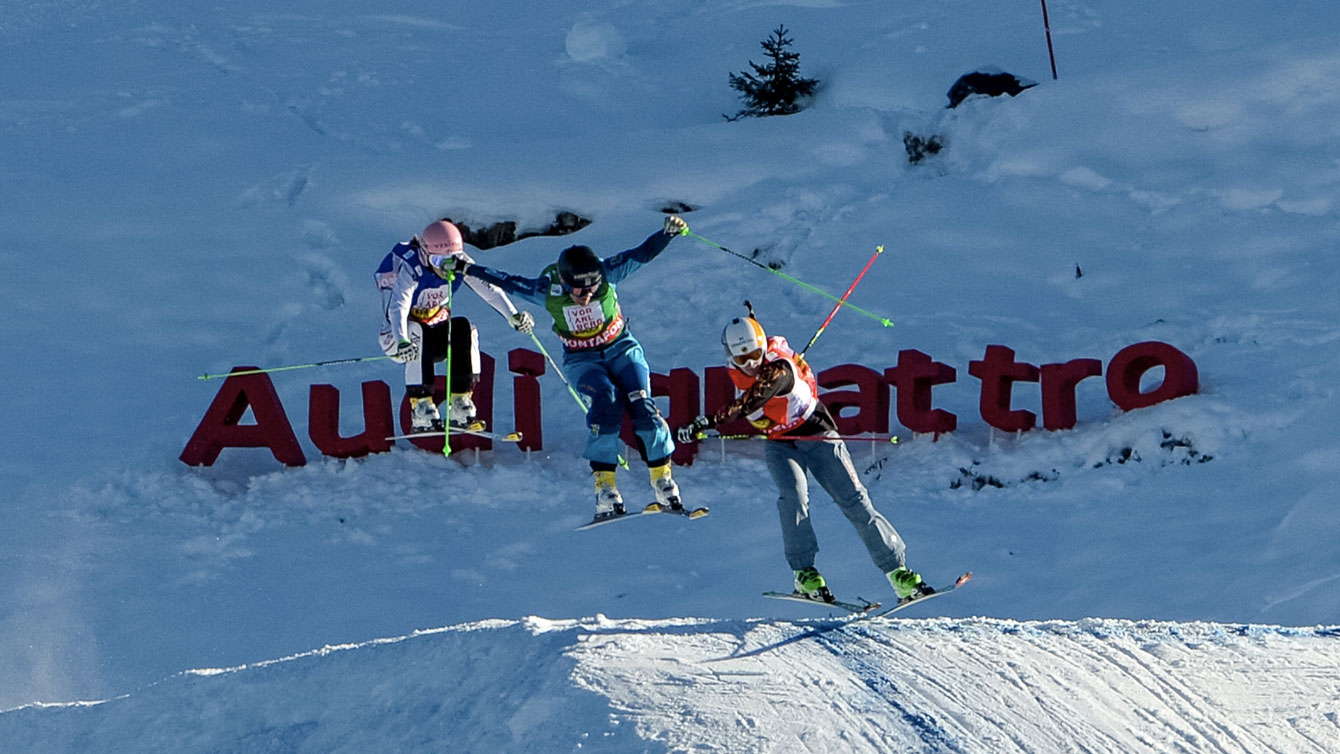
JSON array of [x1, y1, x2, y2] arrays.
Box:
[[0, 0, 1340, 753]]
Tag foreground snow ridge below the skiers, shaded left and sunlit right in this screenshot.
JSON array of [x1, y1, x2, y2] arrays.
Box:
[[0, 617, 1340, 754]]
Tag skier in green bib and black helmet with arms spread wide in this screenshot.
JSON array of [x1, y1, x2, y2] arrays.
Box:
[[457, 214, 689, 521]]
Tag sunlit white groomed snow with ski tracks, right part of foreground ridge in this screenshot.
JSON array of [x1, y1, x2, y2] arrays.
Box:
[[572, 619, 1340, 754]]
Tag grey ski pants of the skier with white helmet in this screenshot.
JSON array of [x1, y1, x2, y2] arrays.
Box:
[[764, 433, 906, 573]]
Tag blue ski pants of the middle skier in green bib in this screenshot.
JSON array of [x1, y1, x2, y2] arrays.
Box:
[[563, 335, 674, 465]]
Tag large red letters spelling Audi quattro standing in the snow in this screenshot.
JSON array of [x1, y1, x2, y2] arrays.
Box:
[[181, 342, 1199, 466]]
